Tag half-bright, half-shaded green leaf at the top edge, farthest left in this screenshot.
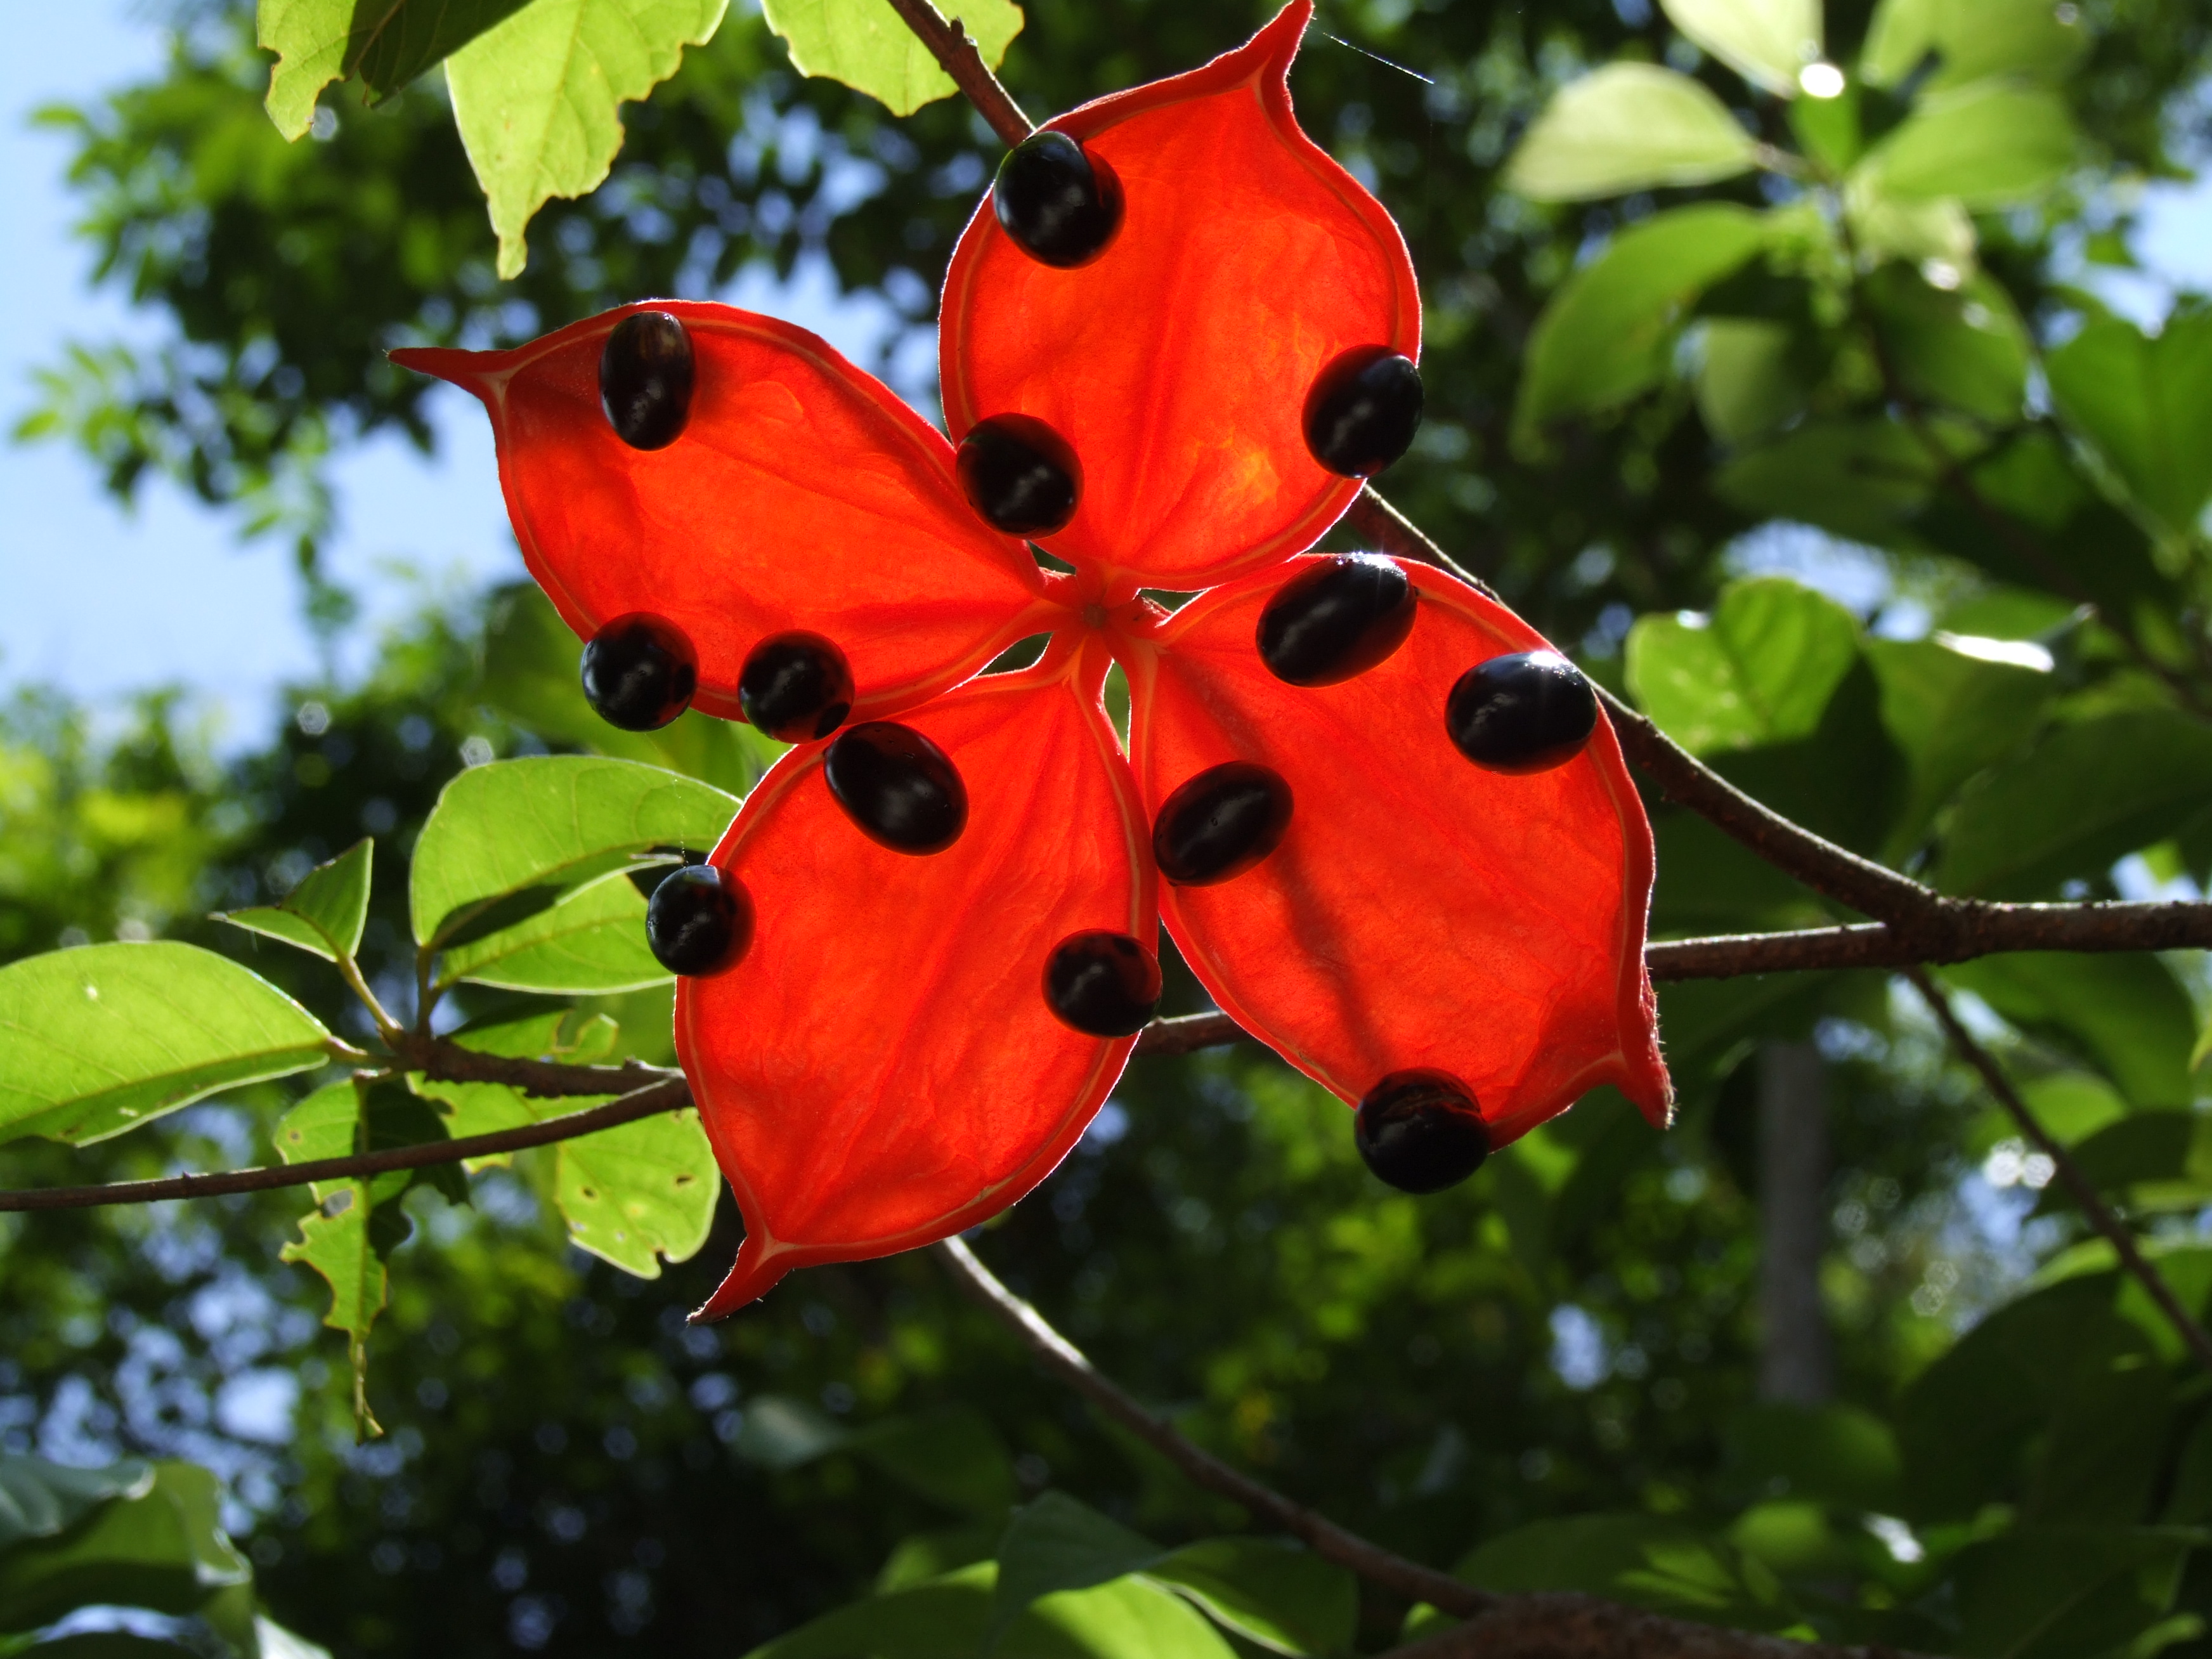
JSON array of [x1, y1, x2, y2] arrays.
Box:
[[254, 0, 526, 140]]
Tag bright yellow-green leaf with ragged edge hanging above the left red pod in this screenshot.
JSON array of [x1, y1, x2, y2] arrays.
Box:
[[445, 0, 728, 278]]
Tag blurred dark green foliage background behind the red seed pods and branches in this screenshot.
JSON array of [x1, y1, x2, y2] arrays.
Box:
[[0, 0, 2212, 1657]]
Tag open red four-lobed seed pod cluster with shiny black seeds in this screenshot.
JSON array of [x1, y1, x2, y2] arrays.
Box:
[[398, 0, 1670, 1316]]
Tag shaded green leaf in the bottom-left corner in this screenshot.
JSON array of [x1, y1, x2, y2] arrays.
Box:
[[0, 1462, 252, 1630]]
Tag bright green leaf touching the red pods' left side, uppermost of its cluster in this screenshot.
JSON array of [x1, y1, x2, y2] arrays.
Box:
[[409, 754, 739, 947]]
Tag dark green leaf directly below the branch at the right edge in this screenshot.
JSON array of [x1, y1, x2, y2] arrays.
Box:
[[1942, 951, 2197, 1110]]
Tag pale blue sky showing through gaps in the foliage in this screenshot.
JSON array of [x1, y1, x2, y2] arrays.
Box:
[[0, 0, 2212, 743]]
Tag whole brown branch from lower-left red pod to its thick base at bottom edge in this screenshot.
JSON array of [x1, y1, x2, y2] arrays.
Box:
[[935, 1239, 1937, 1659]]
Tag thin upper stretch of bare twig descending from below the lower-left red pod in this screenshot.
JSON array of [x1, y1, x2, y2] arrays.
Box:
[[935, 1239, 1497, 1619]]
